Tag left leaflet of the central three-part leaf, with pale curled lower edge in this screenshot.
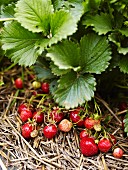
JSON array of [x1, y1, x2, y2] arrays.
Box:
[[46, 40, 80, 71]]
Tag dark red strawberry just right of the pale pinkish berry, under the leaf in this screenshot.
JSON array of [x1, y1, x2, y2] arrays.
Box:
[[69, 108, 84, 127]]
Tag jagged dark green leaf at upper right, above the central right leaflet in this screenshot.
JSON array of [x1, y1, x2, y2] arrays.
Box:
[[83, 13, 112, 35]]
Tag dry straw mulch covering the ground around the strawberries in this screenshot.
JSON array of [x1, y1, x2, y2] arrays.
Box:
[[0, 64, 128, 170]]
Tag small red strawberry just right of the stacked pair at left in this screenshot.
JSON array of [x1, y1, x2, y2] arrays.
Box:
[[32, 111, 44, 123]]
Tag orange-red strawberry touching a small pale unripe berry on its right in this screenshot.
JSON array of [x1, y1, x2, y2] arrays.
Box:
[[84, 117, 100, 129]]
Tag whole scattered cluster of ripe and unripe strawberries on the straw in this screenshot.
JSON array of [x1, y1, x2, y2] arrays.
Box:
[[15, 78, 124, 158]]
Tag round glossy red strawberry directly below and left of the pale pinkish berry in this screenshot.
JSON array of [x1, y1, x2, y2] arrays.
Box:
[[43, 124, 57, 139]]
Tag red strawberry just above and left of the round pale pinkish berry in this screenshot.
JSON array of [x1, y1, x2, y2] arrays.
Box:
[[50, 108, 64, 123]]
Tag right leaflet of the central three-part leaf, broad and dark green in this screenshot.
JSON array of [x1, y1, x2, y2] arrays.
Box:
[[80, 34, 111, 74]]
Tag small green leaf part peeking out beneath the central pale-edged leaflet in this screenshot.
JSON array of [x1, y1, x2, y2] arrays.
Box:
[[50, 62, 70, 76]]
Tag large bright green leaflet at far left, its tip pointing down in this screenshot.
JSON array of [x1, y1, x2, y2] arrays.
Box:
[[2, 21, 41, 66]]
